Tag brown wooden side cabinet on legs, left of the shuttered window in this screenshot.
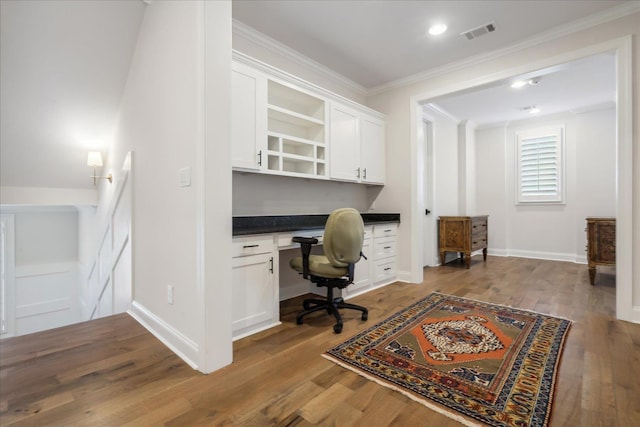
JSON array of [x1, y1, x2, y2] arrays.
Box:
[[438, 215, 489, 268]]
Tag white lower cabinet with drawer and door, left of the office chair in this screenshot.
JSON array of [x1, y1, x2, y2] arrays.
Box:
[[231, 235, 280, 339]]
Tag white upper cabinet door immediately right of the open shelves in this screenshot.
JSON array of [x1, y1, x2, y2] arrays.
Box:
[[329, 105, 360, 182]]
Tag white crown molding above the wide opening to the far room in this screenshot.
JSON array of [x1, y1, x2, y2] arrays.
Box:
[[368, 2, 640, 96]]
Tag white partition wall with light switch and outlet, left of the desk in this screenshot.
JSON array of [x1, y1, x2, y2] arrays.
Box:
[[99, 1, 232, 372]]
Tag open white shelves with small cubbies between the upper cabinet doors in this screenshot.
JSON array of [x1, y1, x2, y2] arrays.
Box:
[[267, 80, 328, 179]]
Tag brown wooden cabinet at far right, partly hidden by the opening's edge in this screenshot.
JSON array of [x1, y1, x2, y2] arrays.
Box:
[[586, 217, 616, 285]]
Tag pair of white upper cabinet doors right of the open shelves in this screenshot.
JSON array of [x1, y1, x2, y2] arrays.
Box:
[[330, 103, 385, 184]]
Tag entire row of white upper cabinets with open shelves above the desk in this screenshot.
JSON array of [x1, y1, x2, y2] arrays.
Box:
[[231, 56, 385, 184]]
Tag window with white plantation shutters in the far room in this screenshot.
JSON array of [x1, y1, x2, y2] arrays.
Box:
[[516, 127, 564, 204]]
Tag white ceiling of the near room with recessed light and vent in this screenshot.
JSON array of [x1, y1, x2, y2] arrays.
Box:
[[233, 0, 629, 89]]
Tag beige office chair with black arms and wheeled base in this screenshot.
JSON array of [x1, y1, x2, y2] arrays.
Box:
[[289, 208, 369, 334]]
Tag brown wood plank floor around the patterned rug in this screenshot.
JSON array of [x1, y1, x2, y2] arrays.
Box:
[[0, 257, 640, 427]]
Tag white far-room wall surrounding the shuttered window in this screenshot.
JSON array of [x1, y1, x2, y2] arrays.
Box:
[[476, 108, 615, 262]]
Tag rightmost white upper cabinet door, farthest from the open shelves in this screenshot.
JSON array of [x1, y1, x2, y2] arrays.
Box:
[[360, 116, 386, 184]]
